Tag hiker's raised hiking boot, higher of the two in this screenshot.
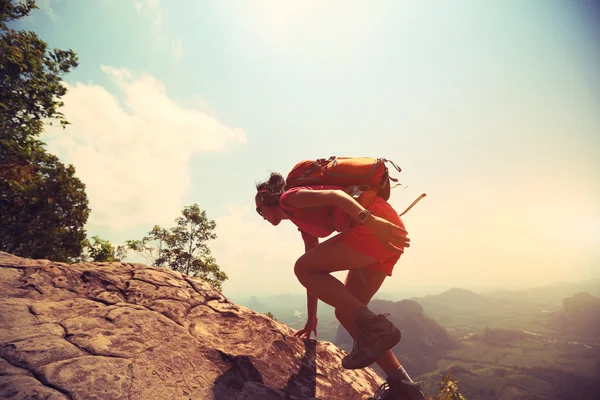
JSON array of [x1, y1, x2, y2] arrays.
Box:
[[342, 314, 401, 369]]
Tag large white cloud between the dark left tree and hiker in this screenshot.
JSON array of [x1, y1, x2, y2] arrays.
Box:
[[42, 66, 246, 231]]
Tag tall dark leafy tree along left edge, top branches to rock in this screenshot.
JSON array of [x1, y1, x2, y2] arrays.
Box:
[[0, 0, 90, 262]]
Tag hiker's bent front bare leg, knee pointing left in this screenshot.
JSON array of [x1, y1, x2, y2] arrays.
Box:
[[294, 235, 375, 316]]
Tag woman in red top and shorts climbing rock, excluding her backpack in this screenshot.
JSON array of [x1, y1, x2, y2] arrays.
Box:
[[255, 173, 425, 400]]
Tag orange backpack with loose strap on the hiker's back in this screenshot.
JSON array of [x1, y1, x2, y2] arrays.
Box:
[[285, 156, 425, 215]]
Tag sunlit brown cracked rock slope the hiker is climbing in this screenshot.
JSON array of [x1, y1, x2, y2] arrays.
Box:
[[0, 252, 383, 400]]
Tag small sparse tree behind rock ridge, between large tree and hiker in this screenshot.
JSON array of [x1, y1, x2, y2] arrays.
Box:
[[126, 204, 228, 290]]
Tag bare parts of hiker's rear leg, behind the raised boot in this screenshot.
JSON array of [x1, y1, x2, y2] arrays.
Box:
[[335, 268, 400, 375]]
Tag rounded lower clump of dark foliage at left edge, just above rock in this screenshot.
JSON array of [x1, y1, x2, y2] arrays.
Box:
[[0, 151, 89, 262]]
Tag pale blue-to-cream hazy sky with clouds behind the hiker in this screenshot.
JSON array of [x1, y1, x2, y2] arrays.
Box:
[[14, 0, 600, 298]]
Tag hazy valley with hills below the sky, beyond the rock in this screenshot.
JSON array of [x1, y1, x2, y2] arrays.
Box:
[[232, 280, 600, 400]]
